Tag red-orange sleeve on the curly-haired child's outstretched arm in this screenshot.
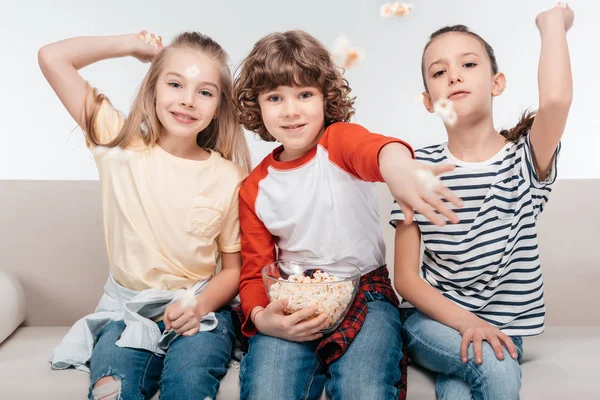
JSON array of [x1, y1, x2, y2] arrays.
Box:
[[319, 122, 415, 182]]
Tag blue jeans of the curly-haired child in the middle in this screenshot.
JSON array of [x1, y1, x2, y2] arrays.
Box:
[[240, 292, 402, 400]]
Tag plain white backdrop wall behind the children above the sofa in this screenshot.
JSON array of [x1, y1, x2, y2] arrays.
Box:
[[0, 0, 600, 180]]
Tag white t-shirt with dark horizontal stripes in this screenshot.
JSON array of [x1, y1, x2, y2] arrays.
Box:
[[390, 135, 560, 336]]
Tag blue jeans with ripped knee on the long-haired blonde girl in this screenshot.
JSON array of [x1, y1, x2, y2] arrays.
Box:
[[88, 307, 235, 400]]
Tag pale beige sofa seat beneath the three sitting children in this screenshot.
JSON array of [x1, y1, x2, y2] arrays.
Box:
[[0, 326, 600, 400]]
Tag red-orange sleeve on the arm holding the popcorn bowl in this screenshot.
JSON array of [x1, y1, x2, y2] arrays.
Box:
[[239, 164, 275, 337]]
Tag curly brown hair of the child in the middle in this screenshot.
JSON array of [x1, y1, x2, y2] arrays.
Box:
[[233, 30, 356, 142]]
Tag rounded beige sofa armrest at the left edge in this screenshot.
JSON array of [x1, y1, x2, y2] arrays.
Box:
[[0, 269, 25, 343]]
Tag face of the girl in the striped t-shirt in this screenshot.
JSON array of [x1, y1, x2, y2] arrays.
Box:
[[423, 32, 506, 121]]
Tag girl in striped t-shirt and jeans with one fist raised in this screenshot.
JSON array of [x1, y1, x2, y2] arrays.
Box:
[[390, 6, 574, 400]]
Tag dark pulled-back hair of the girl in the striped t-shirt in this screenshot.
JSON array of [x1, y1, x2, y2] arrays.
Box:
[[421, 25, 535, 142]]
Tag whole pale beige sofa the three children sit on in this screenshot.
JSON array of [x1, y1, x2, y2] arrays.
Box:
[[0, 180, 600, 400]]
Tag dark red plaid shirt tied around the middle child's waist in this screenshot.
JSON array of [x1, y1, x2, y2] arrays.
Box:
[[232, 265, 409, 400]]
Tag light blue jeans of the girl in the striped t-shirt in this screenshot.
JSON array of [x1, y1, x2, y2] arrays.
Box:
[[402, 309, 523, 400]]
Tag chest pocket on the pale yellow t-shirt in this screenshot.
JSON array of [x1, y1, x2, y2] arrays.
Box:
[[184, 196, 223, 239]]
